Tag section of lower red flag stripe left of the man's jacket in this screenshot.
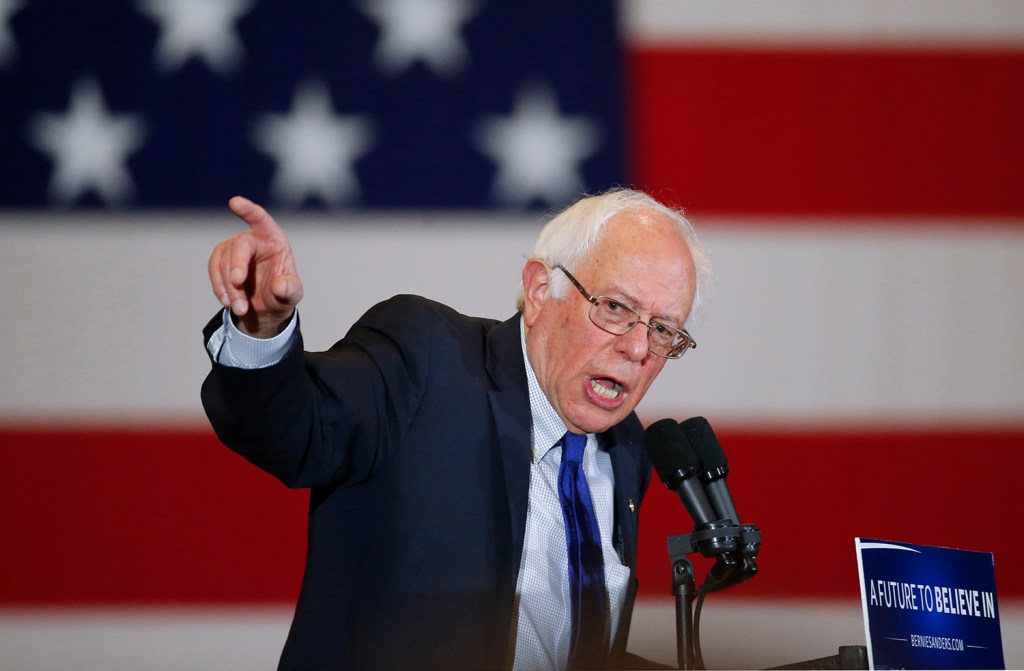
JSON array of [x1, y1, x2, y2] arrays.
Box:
[[0, 429, 308, 604]]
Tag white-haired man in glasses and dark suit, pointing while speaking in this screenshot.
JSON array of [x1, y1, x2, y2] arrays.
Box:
[[203, 190, 708, 669]]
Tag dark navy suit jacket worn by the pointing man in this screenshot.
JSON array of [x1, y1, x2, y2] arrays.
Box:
[[203, 296, 650, 669]]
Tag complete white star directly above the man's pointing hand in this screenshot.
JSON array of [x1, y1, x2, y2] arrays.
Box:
[[255, 82, 373, 205]]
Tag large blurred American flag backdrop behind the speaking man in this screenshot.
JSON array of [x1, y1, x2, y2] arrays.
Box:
[[0, 0, 1024, 670]]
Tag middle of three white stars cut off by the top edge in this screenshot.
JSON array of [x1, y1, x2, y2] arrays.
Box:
[[136, 0, 253, 75]]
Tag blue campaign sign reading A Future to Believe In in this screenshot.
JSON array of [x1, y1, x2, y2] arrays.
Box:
[[856, 538, 1006, 669]]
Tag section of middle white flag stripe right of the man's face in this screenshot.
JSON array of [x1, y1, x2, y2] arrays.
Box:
[[649, 220, 1024, 424]]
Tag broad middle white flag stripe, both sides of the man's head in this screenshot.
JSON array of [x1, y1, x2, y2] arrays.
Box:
[[0, 213, 1024, 425]]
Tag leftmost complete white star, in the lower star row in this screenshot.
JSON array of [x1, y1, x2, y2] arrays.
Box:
[[30, 78, 145, 204]]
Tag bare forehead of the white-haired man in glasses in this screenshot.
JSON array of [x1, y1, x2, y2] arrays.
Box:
[[580, 211, 696, 320]]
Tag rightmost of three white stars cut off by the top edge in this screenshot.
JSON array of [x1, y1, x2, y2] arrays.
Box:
[[362, 0, 475, 77]]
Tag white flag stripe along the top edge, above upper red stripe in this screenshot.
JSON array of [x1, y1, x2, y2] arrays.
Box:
[[621, 0, 1024, 48]]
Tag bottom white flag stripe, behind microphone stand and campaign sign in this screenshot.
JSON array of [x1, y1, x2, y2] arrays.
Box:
[[0, 602, 1024, 671]]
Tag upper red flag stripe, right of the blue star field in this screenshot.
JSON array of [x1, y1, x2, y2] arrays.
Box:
[[628, 48, 1024, 217]]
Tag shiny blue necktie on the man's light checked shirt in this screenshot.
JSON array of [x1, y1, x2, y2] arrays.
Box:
[[558, 432, 608, 669]]
